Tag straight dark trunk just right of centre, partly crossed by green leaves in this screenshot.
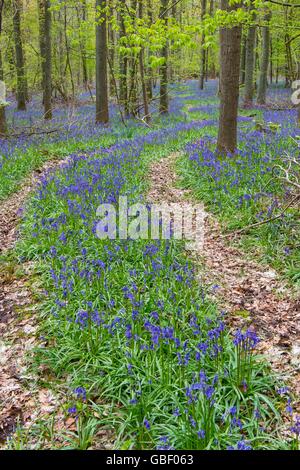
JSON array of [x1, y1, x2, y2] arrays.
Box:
[[159, 0, 169, 114]]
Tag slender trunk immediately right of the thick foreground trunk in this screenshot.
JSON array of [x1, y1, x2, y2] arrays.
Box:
[[244, 4, 256, 107]]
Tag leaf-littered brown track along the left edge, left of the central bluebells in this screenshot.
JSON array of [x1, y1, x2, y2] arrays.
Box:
[[0, 159, 68, 447]]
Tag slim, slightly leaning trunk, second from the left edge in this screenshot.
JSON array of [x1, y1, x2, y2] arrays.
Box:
[[13, 0, 27, 111]]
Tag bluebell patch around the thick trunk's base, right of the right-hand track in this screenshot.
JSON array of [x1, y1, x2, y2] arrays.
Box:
[[179, 81, 300, 283]]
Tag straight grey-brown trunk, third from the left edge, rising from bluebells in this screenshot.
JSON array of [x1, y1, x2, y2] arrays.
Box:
[[38, 0, 52, 119]]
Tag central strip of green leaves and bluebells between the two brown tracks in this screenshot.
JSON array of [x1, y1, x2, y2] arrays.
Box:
[[4, 119, 291, 450]]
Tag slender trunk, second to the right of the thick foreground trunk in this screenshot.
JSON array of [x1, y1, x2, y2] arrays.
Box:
[[257, 13, 271, 104]]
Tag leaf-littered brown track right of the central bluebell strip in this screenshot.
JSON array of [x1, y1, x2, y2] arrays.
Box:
[[148, 153, 300, 410]]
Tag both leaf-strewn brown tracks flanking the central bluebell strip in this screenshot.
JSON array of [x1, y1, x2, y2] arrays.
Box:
[[0, 149, 300, 448]]
